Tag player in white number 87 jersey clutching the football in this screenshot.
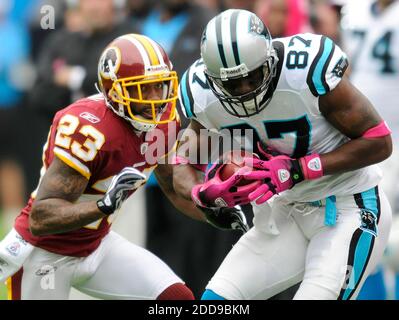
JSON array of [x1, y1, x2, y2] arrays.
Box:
[[174, 9, 392, 299]]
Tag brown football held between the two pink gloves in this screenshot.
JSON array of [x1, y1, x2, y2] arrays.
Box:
[[219, 150, 253, 186]]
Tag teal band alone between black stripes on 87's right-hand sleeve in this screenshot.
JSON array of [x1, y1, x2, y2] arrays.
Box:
[[312, 37, 334, 95]]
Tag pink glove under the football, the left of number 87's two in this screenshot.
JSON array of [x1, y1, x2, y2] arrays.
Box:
[[191, 164, 263, 208]]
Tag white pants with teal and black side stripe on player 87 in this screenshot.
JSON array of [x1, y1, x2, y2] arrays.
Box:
[[207, 188, 392, 300]]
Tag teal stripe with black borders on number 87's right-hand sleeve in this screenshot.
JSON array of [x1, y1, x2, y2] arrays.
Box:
[[307, 36, 335, 97]]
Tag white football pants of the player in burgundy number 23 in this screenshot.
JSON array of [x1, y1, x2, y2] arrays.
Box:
[[8, 231, 183, 300]]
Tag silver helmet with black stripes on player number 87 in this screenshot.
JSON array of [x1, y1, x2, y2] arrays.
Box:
[[201, 9, 278, 117]]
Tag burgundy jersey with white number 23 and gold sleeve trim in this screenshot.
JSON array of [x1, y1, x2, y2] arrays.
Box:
[[15, 95, 179, 257]]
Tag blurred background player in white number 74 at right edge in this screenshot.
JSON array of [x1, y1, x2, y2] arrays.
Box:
[[342, 0, 399, 298]]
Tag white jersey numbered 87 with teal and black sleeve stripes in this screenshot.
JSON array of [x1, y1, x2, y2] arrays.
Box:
[[179, 33, 381, 202]]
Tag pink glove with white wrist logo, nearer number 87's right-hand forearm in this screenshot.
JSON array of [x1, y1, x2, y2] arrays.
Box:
[[242, 145, 323, 204]]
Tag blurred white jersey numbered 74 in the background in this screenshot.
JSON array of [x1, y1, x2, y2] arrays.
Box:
[[342, 0, 399, 140]]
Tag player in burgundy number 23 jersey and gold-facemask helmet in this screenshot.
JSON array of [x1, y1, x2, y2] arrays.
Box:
[[0, 34, 202, 299]]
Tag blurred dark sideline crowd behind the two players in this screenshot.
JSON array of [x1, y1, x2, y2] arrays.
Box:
[[0, 0, 396, 296]]
